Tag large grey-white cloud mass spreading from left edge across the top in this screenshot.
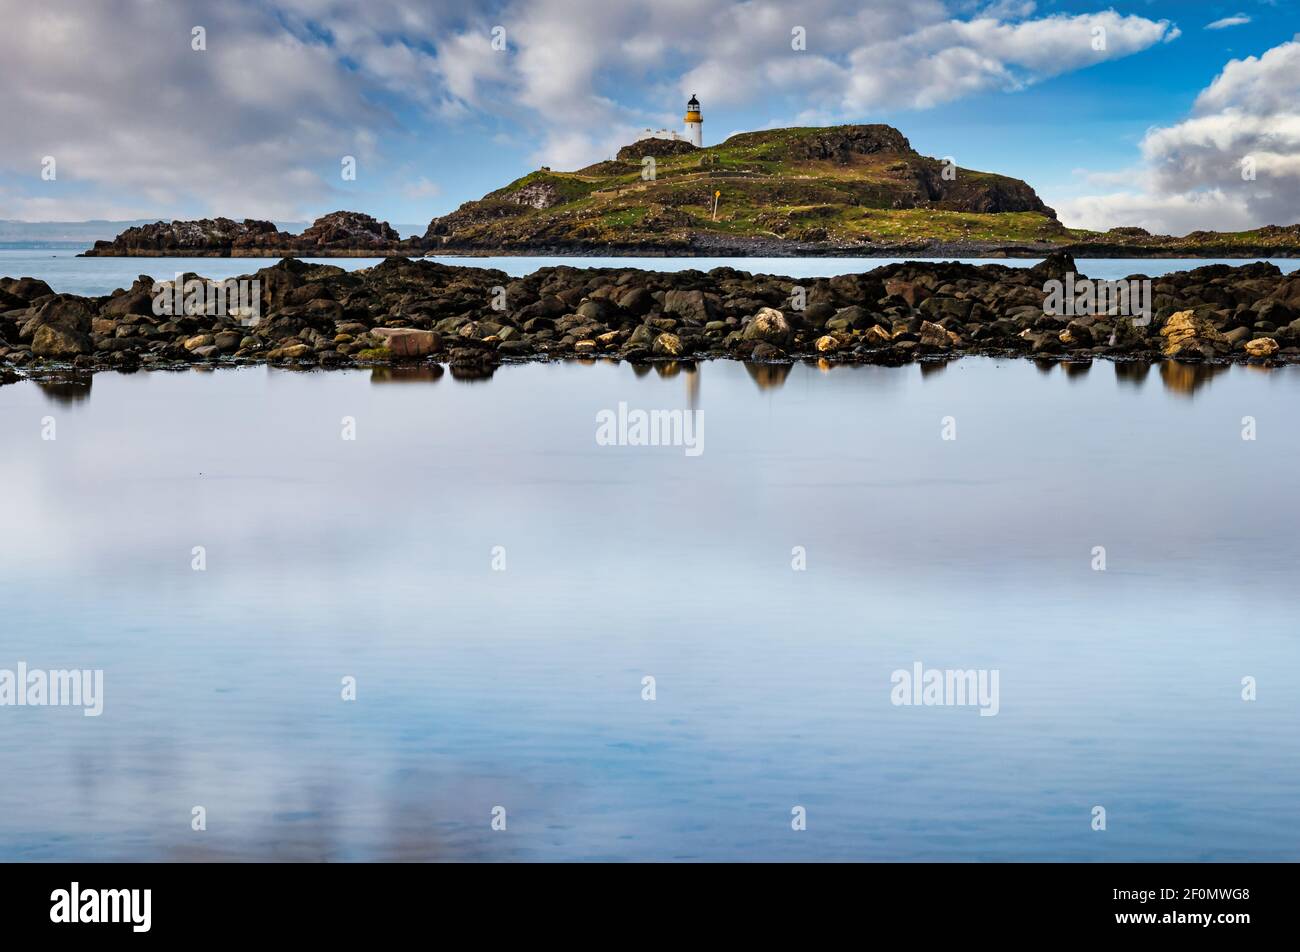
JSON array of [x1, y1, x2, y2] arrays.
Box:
[[0, 0, 1177, 218]]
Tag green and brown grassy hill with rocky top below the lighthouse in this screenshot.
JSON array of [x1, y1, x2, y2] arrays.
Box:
[[425, 125, 1071, 252]]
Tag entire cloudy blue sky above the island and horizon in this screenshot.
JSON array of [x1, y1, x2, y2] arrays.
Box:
[[0, 0, 1300, 234]]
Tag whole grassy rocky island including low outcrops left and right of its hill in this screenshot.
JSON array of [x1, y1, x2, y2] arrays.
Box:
[[85, 125, 1300, 259]]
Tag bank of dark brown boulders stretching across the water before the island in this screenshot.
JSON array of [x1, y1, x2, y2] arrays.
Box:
[[0, 254, 1300, 382]]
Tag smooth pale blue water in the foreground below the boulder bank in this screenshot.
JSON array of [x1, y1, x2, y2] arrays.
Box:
[[0, 358, 1300, 860]]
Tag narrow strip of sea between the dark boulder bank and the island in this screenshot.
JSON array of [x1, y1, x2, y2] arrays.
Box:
[[0, 248, 1300, 295]]
